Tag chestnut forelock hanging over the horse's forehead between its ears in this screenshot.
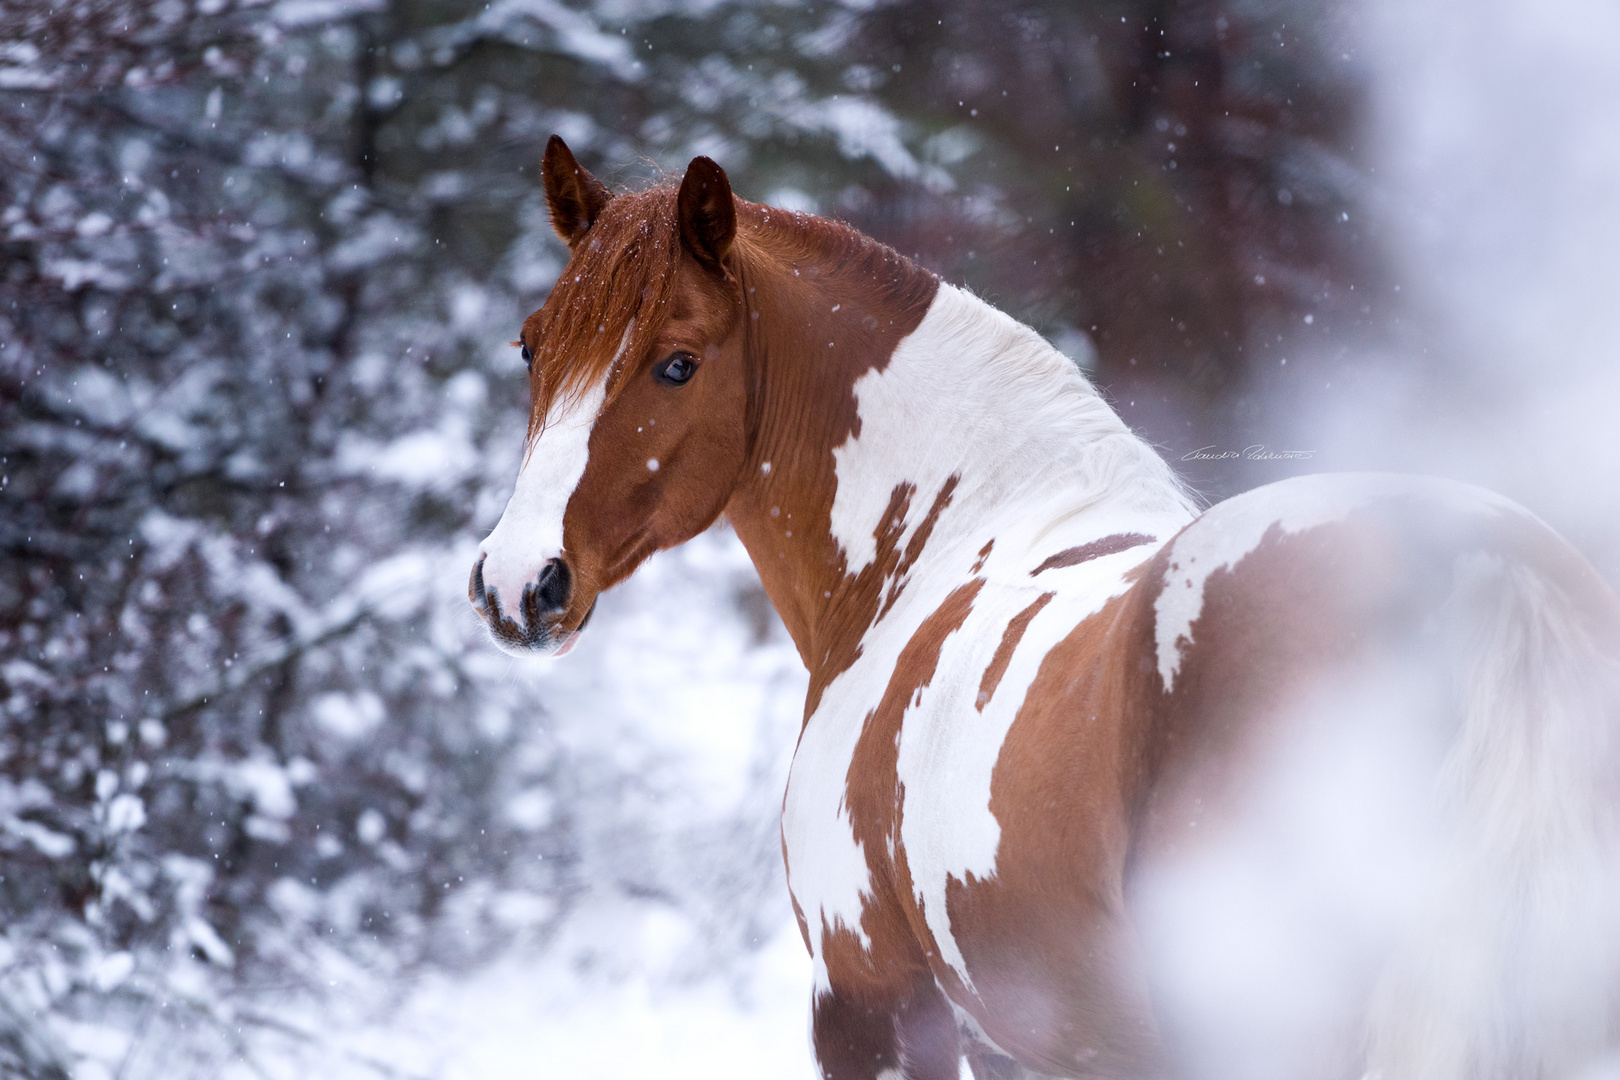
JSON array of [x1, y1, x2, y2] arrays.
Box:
[[528, 185, 680, 444]]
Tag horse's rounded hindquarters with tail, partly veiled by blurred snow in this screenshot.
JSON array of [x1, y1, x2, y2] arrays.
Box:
[[1128, 474, 1620, 1080]]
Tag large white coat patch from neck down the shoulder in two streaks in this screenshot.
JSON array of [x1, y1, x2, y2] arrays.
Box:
[[782, 285, 1192, 989]]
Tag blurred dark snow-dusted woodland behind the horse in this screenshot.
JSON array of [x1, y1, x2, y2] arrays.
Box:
[[0, 0, 1408, 1077]]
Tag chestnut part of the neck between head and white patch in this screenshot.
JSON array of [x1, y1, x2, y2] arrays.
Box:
[[726, 202, 949, 693]]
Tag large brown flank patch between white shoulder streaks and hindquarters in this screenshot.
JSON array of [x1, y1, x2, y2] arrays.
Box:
[[919, 585, 1162, 1077]]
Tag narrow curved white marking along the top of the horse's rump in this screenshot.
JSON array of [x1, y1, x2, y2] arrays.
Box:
[[1153, 473, 1529, 693]]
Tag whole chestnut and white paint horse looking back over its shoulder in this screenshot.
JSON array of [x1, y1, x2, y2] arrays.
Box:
[[471, 138, 1620, 1080]]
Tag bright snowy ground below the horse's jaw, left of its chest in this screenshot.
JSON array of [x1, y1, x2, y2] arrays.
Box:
[[366, 526, 813, 1080]]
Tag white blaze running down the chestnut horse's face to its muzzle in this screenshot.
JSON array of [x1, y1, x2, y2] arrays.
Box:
[[478, 377, 608, 619]]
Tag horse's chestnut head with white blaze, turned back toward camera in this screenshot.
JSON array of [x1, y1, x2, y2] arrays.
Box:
[[470, 136, 748, 654]]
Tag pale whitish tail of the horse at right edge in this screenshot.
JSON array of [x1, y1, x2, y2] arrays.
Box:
[[1367, 540, 1620, 1080]]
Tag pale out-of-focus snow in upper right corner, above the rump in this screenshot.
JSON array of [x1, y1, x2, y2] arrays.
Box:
[[1294, 0, 1620, 581]]
